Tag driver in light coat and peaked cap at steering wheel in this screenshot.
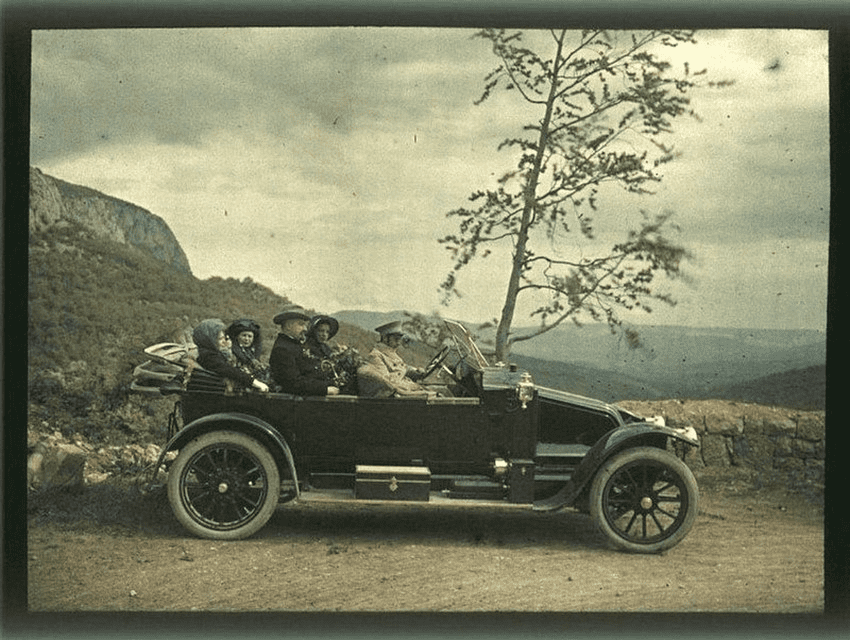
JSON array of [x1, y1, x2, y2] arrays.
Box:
[[357, 321, 433, 398]]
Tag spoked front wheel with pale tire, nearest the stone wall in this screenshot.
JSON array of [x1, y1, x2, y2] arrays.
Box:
[[590, 447, 699, 553]]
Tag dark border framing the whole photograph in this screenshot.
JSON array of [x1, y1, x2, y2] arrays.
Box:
[[0, 0, 850, 639]]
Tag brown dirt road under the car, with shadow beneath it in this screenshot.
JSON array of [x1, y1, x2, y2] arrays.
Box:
[[28, 478, 824, 613]]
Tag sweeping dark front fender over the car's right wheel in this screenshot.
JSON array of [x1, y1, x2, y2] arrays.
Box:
[[534, 422, 699, 511]]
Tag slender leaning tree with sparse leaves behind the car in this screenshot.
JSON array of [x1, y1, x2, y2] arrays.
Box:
[[440, 29, 729, 360]]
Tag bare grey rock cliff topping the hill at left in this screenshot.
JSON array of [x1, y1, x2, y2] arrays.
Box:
[[29, 167, 191, 273]]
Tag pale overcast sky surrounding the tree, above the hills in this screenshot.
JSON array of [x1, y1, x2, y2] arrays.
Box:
[[30, 27, 829, 330]]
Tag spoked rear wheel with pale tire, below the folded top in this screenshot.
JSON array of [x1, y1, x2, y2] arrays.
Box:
[[168, 431, 280, 540]]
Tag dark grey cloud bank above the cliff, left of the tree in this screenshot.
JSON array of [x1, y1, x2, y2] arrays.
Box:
[[32, 28, 494, 162]]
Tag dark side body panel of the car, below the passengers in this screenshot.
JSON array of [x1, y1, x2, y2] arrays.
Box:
[[183, 393, 496, 473]]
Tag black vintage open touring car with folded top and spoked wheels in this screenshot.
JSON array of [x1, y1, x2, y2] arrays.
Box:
[[133, 321, 699, 553]]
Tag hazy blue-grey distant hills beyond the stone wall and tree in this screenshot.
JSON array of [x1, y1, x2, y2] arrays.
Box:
[[335, 310, 826, 409]]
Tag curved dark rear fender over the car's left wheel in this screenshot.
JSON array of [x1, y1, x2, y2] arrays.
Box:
[[155, 412, 301, 497]]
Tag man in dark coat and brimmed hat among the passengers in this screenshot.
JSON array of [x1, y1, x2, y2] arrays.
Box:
[[269, 304, 339, 396]]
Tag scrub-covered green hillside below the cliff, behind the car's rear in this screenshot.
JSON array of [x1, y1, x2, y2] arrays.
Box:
[[28, 224, 375, 443]]
